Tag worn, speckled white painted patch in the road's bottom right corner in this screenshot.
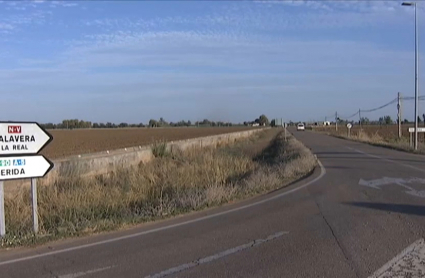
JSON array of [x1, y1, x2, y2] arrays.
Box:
[[369, 238, 425, 278]]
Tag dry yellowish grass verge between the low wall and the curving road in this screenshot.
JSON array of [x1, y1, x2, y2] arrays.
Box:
[[0, 129, 316, 248]]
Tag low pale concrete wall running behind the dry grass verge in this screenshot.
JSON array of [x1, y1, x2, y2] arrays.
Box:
[[5, 128, 267, 195]]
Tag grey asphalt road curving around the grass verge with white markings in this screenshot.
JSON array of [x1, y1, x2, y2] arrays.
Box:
[[0, 131, 425, 278]]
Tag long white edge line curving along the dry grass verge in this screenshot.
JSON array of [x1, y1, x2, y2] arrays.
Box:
[[0, 160, 326, 266]]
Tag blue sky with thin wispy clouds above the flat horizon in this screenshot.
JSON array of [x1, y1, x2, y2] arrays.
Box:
[[0, 0, 425, 123]]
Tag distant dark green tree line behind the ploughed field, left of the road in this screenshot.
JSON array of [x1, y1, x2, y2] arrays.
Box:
[[41, 115, 269, 129]]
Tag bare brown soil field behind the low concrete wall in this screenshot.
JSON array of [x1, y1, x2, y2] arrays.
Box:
[[41, 127, 253, 159]]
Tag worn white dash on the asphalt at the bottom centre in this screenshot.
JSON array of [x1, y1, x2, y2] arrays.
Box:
[[146, 232, 289, 278]]
